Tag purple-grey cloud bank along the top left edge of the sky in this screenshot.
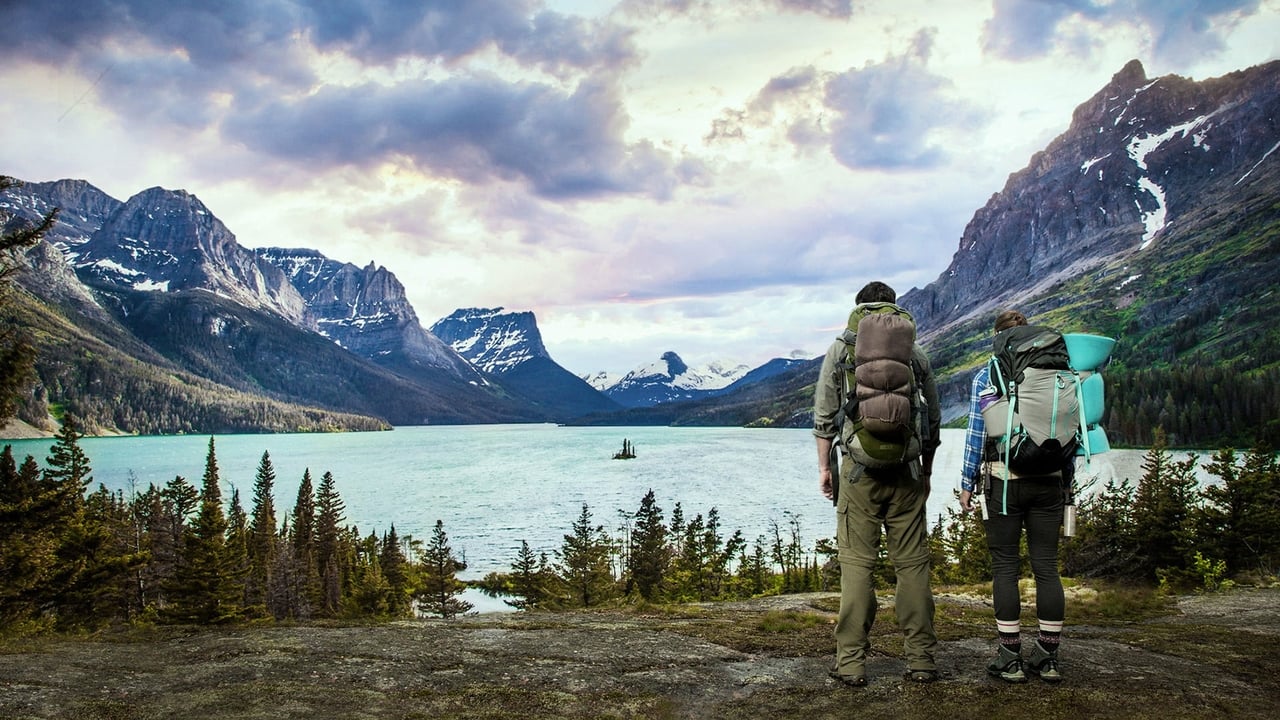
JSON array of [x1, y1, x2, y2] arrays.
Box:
[[0, 0, 636, 129]]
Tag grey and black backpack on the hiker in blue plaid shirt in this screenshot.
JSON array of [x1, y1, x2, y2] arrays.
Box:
[[982, 325, 1082, 475]]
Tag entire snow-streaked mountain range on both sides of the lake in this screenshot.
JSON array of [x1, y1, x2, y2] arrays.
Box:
[[0, 61, 1280, 443]]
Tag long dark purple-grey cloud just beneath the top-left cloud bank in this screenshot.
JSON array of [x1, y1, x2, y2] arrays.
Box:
[[225, 76, 678, 197]]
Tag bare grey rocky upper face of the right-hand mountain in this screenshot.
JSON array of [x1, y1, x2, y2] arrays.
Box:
[[902, 60, 1280, 337]]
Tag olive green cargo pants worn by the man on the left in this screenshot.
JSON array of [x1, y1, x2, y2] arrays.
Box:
[[835, 461, 938, 675]]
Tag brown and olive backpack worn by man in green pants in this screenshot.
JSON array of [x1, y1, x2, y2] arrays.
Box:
[[841, 302, 928, 468]]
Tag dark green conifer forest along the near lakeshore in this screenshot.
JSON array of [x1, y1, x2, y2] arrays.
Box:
[[0, 418, 1280, 633]]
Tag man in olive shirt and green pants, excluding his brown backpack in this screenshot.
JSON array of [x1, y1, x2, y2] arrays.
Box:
[[813, 275, 941, 687]]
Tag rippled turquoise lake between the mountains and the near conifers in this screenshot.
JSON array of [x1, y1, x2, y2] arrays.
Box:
[[0, 424, 1204, 609]]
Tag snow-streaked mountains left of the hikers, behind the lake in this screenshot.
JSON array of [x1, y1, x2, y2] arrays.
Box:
[[0, 179, 788, 433]]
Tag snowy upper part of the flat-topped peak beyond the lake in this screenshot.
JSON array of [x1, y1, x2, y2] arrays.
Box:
[[431, 307, 549, 375]]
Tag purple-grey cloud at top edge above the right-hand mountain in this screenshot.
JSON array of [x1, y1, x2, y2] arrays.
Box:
[[983, 0, 1260, 61]]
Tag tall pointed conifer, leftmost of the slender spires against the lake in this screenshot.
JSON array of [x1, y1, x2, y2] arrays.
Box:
[[168, 438, 243, 624]]
